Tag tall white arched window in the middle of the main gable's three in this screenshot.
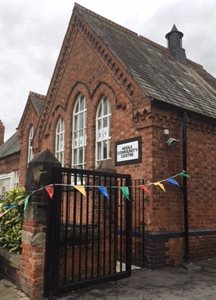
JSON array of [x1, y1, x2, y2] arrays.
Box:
[[72, 94, 87, 169]]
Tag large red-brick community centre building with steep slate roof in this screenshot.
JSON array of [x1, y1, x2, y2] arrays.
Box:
[[0, 4, 216, 265]]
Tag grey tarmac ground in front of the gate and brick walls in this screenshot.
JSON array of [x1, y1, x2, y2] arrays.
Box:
[[0, 258, 216, 300]]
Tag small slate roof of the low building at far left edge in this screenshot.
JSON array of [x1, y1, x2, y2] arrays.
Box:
[[0, 132, 20, 159]]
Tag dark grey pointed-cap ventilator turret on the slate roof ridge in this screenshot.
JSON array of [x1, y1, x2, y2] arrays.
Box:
[[166, 25, 187, 64]]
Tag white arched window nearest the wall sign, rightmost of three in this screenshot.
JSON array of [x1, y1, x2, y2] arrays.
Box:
[[95, 96, 111, 166]]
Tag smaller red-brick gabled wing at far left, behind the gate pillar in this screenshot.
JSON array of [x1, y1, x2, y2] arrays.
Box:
[[0, 92, 45, 196]]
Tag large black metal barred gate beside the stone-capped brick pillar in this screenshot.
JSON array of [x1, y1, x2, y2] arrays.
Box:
[[44, 168, 132, 296]]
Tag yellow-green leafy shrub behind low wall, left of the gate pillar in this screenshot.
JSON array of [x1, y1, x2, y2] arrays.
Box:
[[0, 188, 25, 253]]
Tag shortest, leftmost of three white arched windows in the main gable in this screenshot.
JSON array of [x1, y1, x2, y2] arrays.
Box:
[[55, 118, 65, 166]]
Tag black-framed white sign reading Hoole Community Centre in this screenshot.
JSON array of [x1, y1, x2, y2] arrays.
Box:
[[115, 137, 141, 165]]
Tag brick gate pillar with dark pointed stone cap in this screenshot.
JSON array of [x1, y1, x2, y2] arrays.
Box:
[[18, 150, 61, 299]]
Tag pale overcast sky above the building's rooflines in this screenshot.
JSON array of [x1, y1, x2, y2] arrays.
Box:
[[0, 0, 216, 140]]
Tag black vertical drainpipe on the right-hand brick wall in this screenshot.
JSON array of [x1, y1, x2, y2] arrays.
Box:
[[182, 112, 191, 264]]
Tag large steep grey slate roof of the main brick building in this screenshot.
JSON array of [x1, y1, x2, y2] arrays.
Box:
[[74, 4, 216, 118]]
